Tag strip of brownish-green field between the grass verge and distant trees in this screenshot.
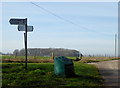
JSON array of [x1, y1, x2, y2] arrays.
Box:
[[2, 55, 120, 63]]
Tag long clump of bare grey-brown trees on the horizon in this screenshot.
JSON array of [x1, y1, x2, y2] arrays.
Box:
[[13, 48, 80, 57]]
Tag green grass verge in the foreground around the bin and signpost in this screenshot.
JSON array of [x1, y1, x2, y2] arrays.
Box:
[[2, 62, 103, 88]]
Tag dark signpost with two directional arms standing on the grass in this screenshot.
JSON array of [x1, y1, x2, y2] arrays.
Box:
[[9, 18, 33, 70]]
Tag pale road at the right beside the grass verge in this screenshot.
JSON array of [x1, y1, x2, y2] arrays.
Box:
[[89, 60, 120, 88]]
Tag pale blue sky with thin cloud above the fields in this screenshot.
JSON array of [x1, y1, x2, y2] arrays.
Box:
[[2, 2, 118, 55]]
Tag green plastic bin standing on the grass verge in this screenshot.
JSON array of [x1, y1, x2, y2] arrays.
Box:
[[54, 56, 75, 77]]
